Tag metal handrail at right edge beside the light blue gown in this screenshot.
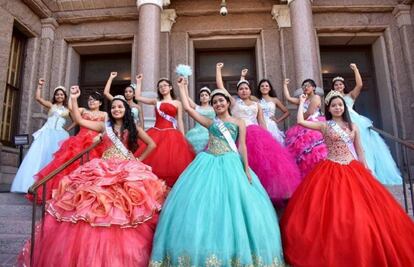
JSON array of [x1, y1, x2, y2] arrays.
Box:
[[369, 126, 414, 215]]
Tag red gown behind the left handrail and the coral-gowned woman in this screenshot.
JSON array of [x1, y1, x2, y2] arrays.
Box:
[[33, 111, 105, 201]]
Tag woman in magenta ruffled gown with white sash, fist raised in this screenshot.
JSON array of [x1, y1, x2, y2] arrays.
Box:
[[283, 79, 328, 177]]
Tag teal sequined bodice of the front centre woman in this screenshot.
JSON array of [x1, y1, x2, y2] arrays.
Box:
[[207, 122, 239, 155]]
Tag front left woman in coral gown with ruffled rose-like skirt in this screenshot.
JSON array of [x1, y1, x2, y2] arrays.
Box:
[[18, 86, 167, 267]]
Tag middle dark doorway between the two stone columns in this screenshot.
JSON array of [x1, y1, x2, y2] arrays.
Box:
[[194, 48, 257, 103]]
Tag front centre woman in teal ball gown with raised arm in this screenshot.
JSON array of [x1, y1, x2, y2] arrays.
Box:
[[150, 78, 285, 266]]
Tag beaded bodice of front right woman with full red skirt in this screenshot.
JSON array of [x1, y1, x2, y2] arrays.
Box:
[[323, 124, 355, 164]]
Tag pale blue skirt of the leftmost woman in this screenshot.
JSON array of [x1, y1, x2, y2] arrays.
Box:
[[10, 128, 69, 193]]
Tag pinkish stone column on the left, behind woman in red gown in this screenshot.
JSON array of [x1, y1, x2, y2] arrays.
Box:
[[136, 0, 163, 127]]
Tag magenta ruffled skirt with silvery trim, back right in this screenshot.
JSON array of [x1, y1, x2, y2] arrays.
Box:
[[285, 117, 328, 177]]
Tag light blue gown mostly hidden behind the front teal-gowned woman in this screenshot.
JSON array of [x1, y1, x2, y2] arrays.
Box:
[[185, 106, 216, 154]]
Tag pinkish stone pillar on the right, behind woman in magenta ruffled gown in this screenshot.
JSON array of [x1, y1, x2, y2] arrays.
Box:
[[288, 0, 321, 86]]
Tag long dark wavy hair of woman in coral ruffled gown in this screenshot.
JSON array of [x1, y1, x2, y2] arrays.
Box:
[[108, 98, 138, 153]]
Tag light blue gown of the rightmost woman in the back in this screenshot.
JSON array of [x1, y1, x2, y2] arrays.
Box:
[[344, 95, 402, 185]]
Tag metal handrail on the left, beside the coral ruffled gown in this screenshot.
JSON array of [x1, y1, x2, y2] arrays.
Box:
[[28, 139, 102, 266]]
